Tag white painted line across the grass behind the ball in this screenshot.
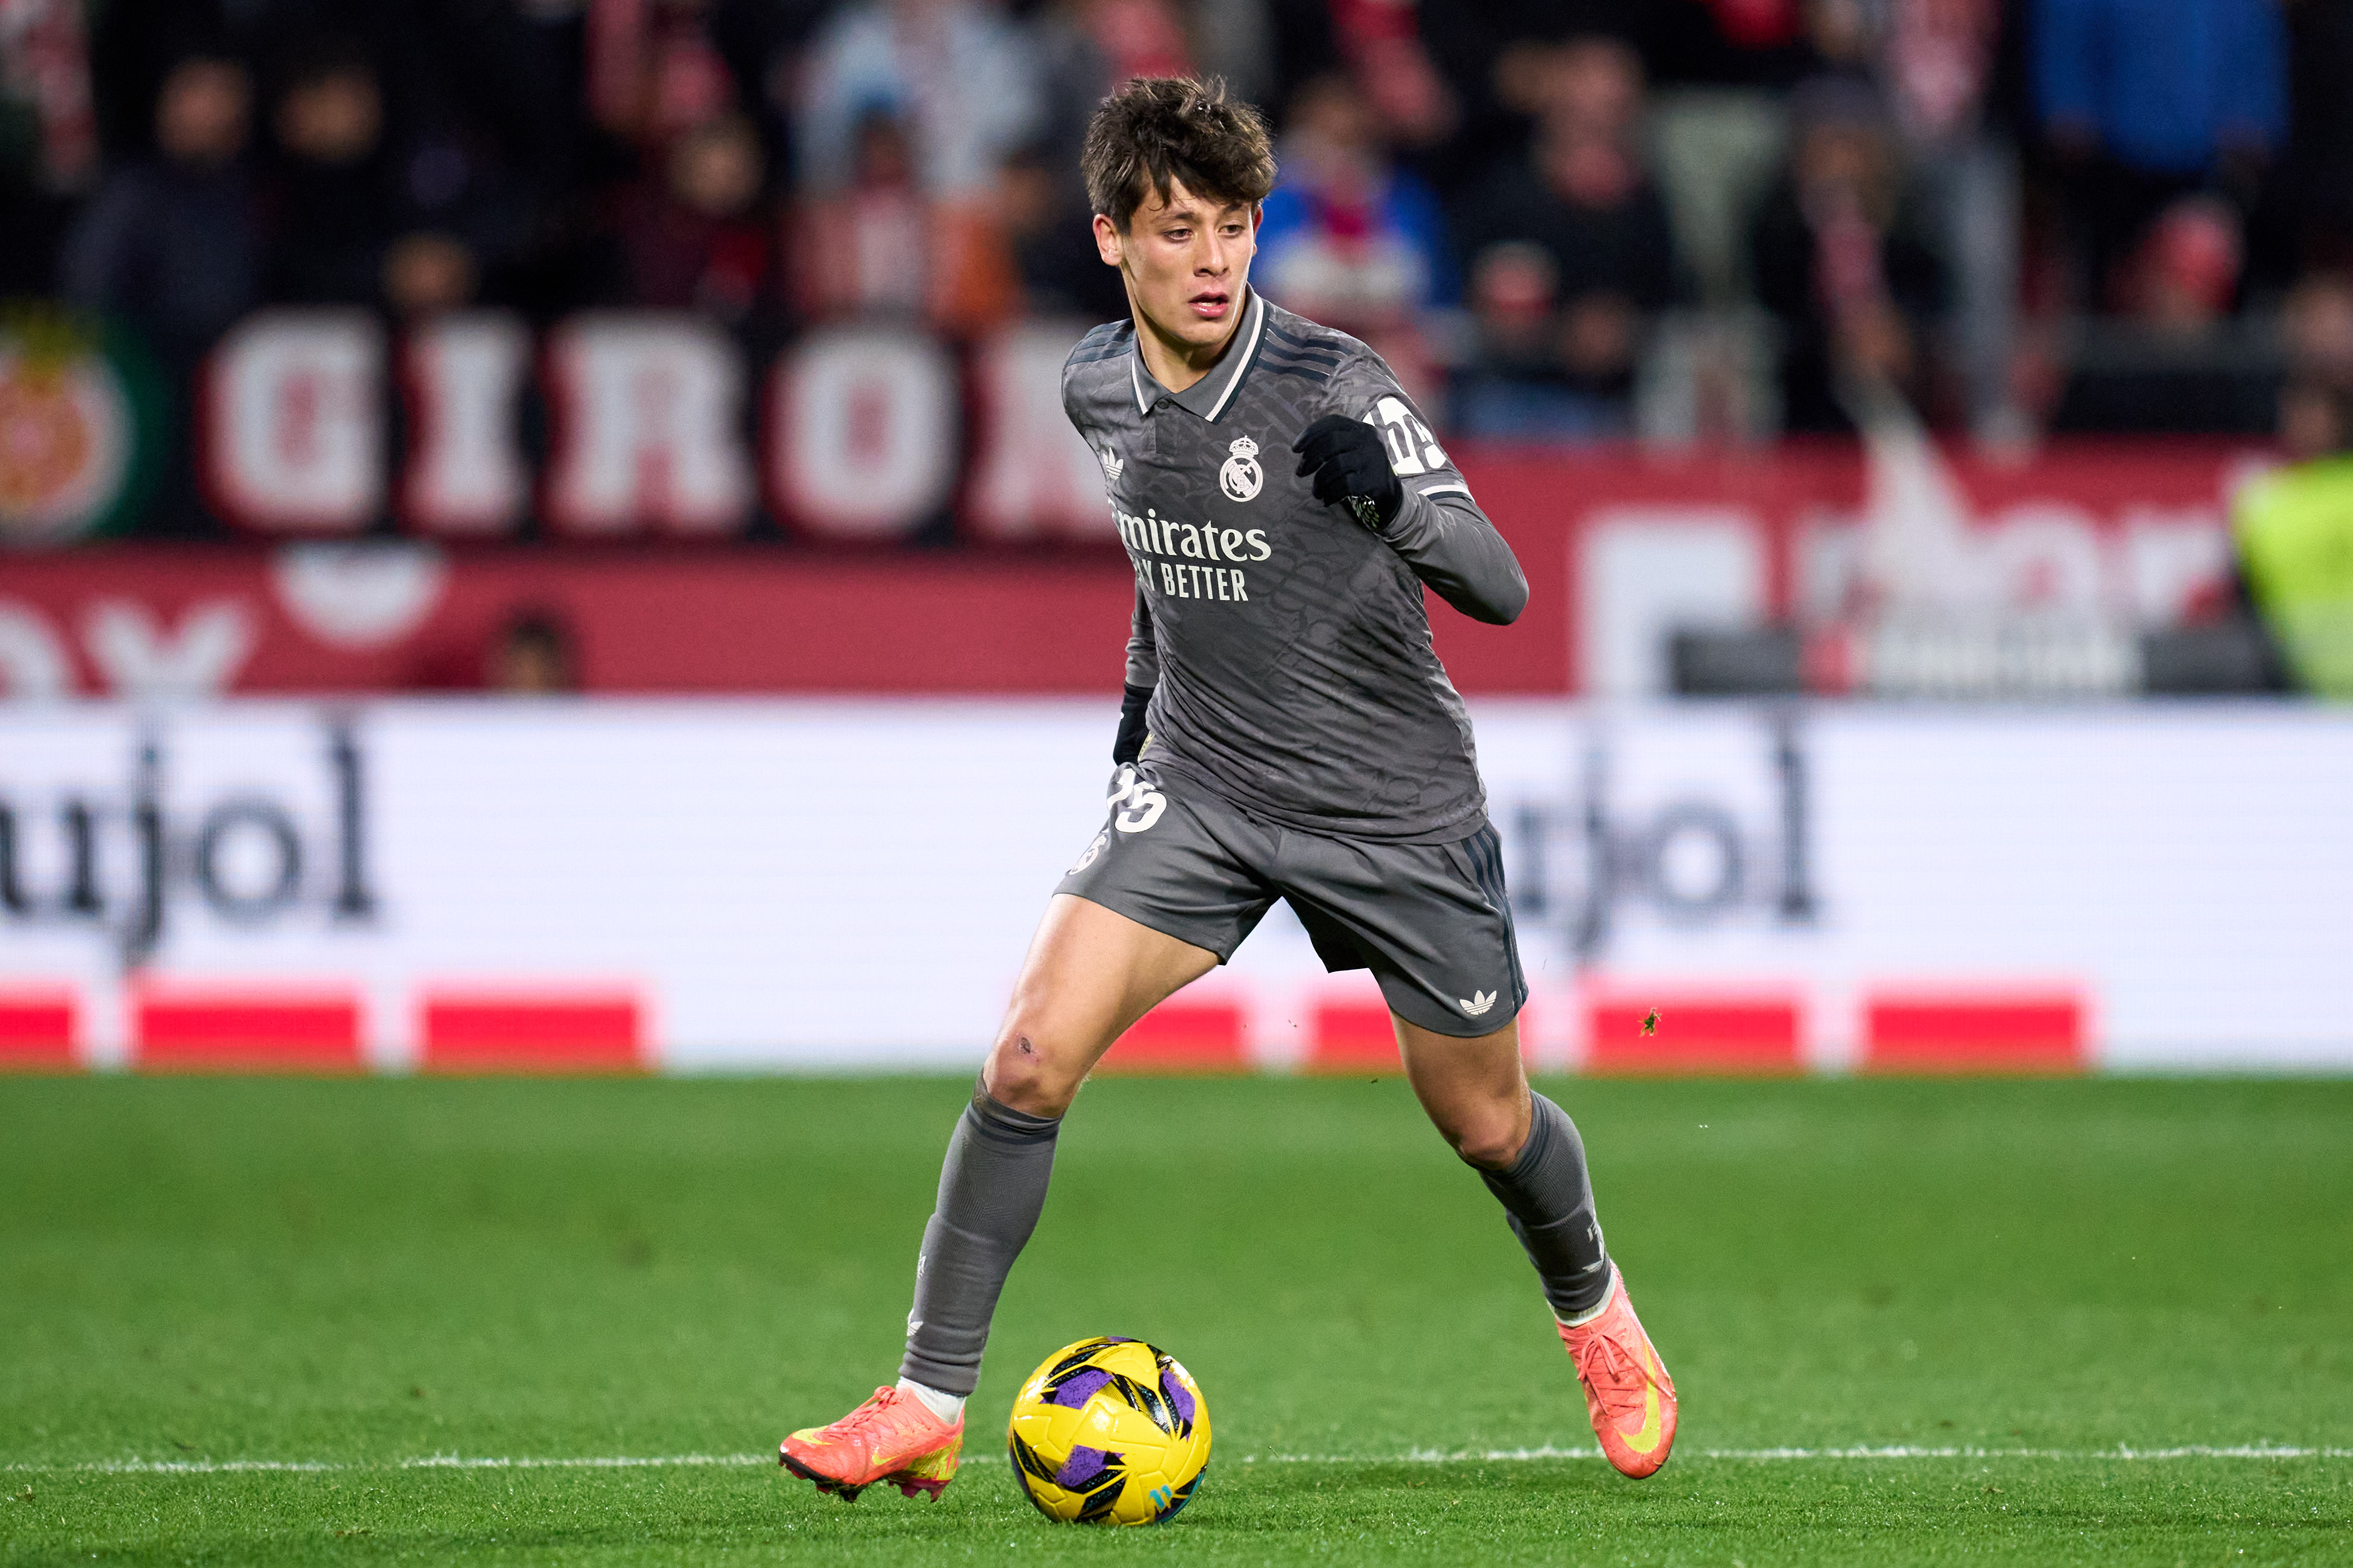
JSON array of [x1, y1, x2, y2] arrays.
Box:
[[0, 1443, 2353, 1476]]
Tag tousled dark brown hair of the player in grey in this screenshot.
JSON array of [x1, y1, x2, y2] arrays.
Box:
[[1078, 75, 1275, 230]]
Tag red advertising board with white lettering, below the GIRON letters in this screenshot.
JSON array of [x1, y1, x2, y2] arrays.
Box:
[[0, 442, 2254, 698]]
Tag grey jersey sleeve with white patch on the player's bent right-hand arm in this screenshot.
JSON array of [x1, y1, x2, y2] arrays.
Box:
[[1325, 350, 1527, 625]]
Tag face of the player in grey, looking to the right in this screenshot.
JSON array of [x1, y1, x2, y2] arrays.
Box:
[[1094, 181, 1259, 352]]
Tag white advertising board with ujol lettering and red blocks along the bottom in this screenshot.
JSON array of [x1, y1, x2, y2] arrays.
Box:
[[0, 700, 2353, 1072]]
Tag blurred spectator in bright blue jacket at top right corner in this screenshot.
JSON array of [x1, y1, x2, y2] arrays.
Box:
[[2031, 0, 2287, 305]]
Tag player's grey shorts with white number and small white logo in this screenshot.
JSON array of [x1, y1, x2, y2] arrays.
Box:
[[1056, 762, 1527, 1037]]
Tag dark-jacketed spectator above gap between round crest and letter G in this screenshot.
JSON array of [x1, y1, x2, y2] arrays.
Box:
[[59, 49, 261, 359]]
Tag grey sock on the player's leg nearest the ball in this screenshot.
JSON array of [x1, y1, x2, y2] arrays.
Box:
[[899, 1086, 1061, 1394]]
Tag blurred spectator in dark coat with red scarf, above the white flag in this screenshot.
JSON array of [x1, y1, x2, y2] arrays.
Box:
[[1748, 78, 1946, 430]]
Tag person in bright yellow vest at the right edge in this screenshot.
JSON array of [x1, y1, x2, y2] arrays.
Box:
[[2230, 381, 2353, 700]]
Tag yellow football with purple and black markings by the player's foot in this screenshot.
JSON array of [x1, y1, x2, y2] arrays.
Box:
[[1005, 1340, 1209, 1523]]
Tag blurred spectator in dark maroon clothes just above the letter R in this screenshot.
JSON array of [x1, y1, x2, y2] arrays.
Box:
[[617, 115, 777, 327]]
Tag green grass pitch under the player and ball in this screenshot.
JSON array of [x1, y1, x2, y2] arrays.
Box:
[[0, 1077, 2353, 1568]]
